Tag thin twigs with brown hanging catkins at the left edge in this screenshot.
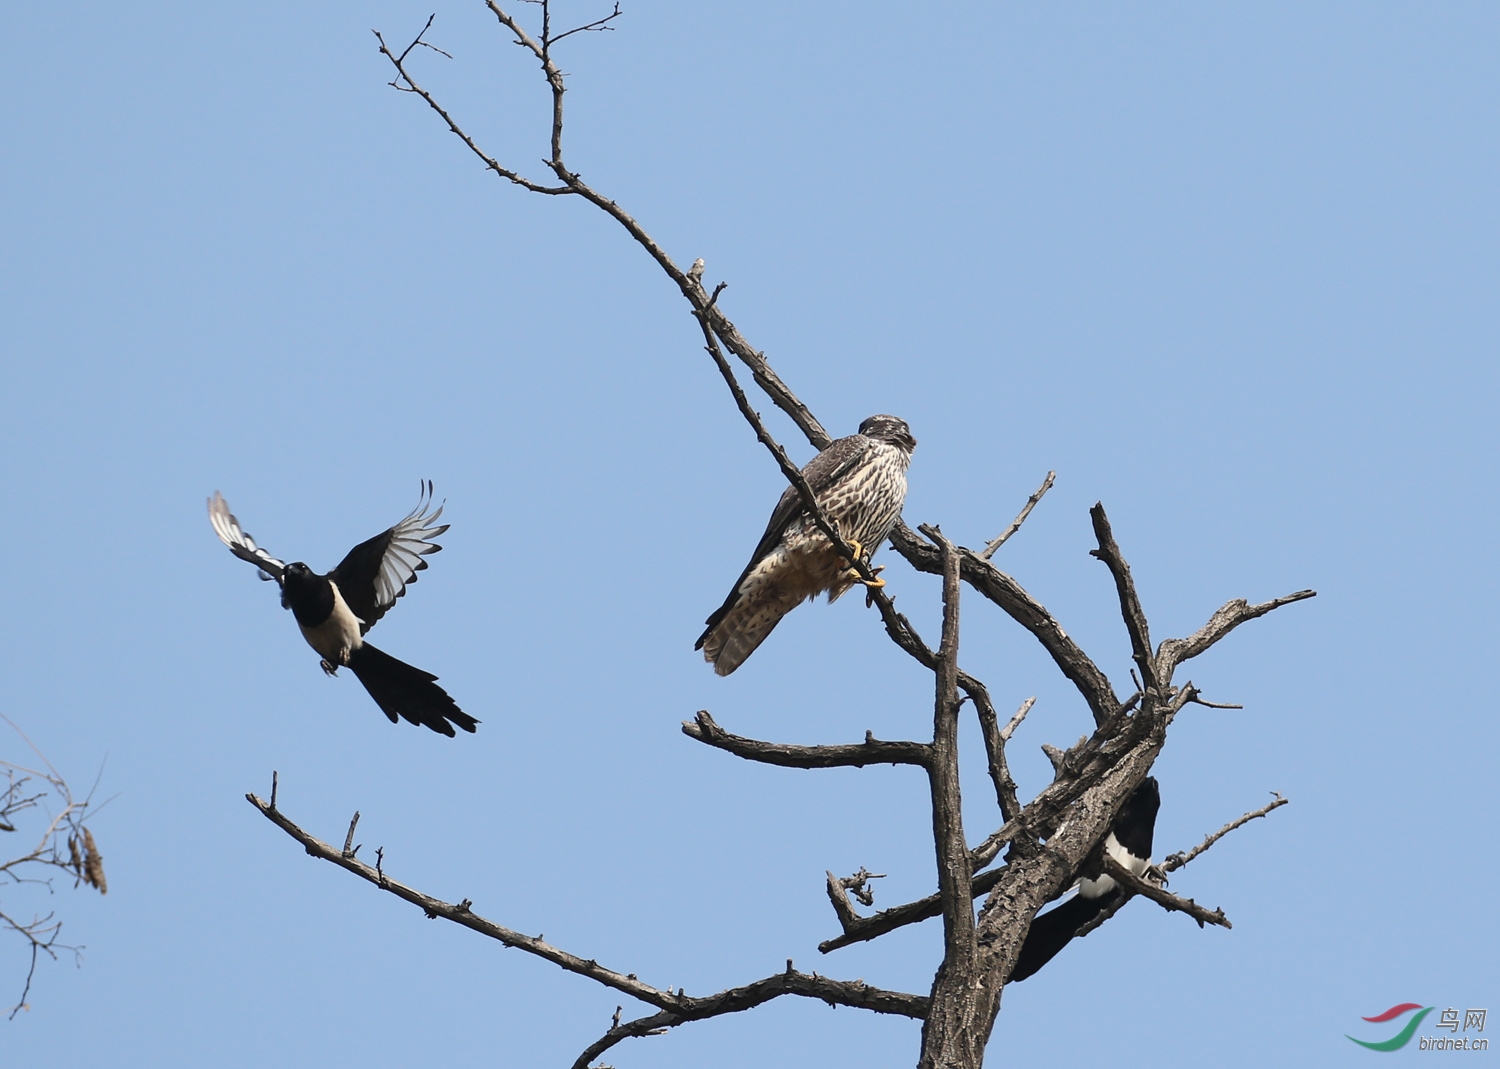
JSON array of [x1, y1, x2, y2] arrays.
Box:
[[0, 715, 108, 1018]]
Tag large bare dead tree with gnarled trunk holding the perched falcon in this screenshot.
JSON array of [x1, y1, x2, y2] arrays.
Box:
[[248, 0, 1313, 1069]]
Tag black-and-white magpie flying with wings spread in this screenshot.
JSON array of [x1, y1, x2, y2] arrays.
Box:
[[209, 481, 479, 738]]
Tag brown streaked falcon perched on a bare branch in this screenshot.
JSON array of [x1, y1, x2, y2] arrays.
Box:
[[693, 415, 917, 676]]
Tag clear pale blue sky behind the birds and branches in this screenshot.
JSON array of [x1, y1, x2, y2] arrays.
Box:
[[0, 0, 1500, 1069]]
